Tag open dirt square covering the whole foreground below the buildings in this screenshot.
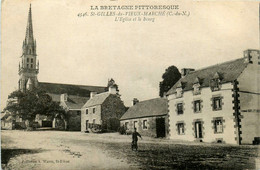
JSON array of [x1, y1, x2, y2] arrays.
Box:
[[1, 131, 260, 170]]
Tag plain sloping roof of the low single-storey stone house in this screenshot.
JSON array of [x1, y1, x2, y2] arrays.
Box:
[[120, 98, 168, 120]]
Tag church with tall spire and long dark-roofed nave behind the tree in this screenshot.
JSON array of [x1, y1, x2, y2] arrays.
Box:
[[16, 5, 107, 131]]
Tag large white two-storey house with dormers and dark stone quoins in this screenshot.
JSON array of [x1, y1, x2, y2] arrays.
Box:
[[166, 50, 260, 144]]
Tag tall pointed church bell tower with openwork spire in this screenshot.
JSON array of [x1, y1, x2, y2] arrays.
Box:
[[18, 4, 39, 92]]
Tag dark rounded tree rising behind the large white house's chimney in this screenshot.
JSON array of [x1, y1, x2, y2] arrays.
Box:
[[159, 66, 181, 97]]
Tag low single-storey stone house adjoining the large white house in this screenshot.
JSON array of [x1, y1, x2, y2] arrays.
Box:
[[120, 98, 169, 137]]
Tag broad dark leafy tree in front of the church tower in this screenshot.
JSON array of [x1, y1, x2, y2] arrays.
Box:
[[4, 88, 66, 128]]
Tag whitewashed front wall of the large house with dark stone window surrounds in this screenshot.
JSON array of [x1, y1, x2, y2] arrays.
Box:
[[168, 83, 236, 143]]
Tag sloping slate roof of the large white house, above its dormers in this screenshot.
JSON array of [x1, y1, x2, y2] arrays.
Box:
[[166, 58, 248, 95]]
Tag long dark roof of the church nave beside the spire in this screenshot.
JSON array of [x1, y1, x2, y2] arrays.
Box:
[[38, 82, 106, 97]]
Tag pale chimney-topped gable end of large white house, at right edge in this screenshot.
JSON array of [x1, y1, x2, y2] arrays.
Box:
[[237, 50, 260, 144]]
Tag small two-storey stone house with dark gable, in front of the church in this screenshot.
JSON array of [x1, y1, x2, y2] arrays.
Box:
[[81, 85, 125, 132]]
